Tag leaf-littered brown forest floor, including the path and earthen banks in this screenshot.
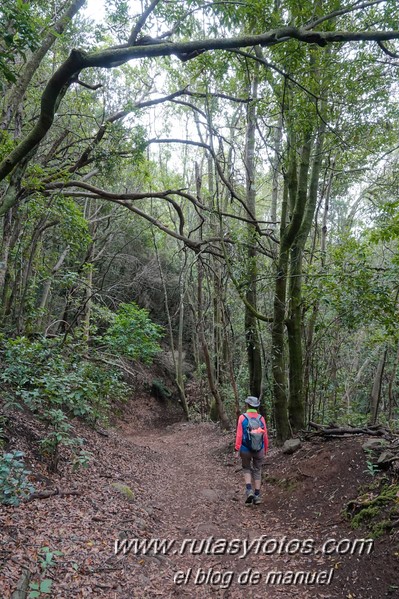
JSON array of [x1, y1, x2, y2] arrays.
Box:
[[0, 396, 399, 599]]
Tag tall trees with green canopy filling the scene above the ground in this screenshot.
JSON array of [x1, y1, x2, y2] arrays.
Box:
[[0, 0, 399, 441]]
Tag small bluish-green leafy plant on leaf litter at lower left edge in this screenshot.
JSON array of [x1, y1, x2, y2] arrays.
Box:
[[0, 451, 35, 506]]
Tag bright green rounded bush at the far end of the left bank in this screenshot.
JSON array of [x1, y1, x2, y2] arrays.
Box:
[[102, 302, 163, 364]]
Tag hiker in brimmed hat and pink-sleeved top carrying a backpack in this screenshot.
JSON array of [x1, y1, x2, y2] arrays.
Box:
[[235, 396, 269, 506]]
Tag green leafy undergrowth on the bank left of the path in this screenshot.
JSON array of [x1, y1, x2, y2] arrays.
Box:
[[0, 303, 162, 504]]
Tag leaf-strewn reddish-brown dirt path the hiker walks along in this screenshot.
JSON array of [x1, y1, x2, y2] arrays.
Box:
[[121, 423, 334, 599]]
